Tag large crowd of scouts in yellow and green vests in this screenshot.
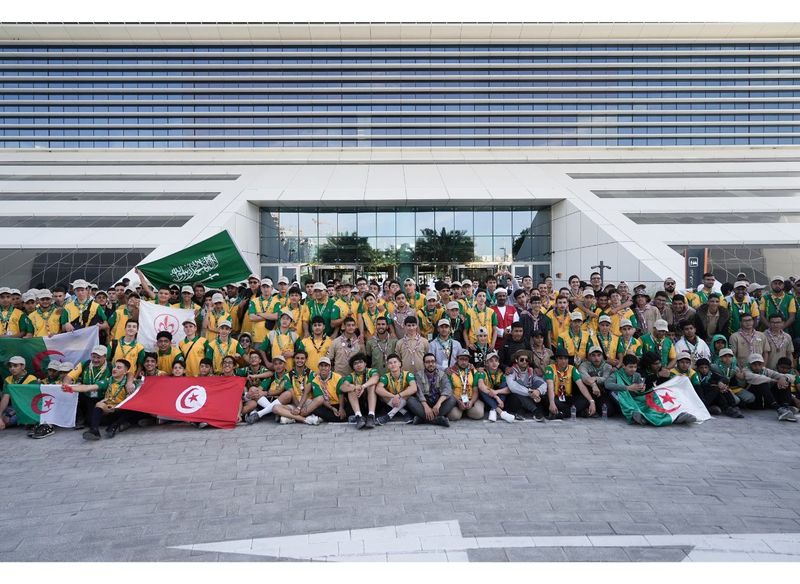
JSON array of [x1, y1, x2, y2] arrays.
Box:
[[0, 271, 800, 440]]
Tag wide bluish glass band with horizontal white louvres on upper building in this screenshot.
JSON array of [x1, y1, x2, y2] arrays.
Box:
[[0, 43, 800, 148]]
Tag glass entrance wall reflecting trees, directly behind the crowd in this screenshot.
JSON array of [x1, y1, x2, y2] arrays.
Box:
[[261, 206, 550, 266]]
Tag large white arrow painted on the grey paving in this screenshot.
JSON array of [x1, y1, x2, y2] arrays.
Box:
[[174, 521, 800, 562]]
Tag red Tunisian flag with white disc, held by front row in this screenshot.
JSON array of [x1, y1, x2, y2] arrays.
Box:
[[117, 376, 247, 429]]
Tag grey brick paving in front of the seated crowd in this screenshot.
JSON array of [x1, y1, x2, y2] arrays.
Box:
[[0, 412, 800, 561]]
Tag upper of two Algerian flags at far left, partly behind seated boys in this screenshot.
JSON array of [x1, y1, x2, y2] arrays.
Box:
[[0, 325, 100, 379]]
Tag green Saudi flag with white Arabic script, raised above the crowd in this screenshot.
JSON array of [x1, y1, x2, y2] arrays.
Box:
[[139, 231, 251, 287]]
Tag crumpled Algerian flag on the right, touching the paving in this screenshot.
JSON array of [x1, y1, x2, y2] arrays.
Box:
[[617, 375, 711, 426]]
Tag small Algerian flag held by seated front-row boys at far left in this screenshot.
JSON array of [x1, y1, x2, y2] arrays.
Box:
[[6, 383, 78, 428]]
